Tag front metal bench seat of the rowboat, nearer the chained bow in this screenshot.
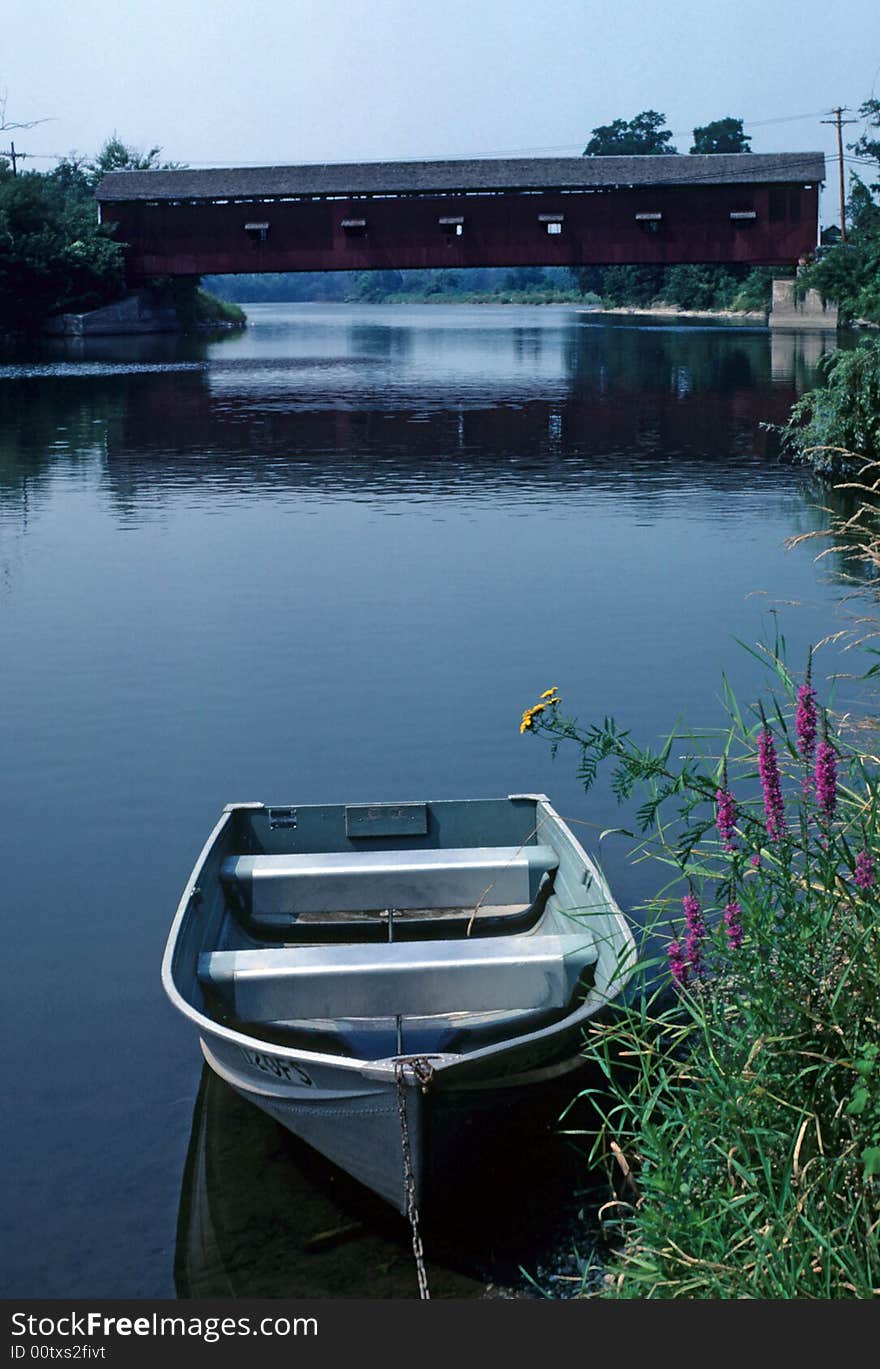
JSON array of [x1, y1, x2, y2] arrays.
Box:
[[198, 930, 597, 1023]]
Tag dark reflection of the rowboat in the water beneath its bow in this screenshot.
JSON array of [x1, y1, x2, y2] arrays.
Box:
[[174, 1065, 602, 1298]]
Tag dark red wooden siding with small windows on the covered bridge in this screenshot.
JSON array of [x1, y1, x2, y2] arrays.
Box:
[[103, 182, 818, 278]]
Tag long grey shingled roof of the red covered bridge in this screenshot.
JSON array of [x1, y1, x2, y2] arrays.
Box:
[[97, 152, 825, 203]]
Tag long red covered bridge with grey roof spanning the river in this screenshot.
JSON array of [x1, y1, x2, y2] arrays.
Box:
[[97, 152, 825, 281]]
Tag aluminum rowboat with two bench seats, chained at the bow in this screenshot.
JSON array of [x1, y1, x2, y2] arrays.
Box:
[[161, 794, 635, 1212]]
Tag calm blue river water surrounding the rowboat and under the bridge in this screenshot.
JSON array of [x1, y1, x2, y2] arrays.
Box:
[[0, 304, 859, 1298]]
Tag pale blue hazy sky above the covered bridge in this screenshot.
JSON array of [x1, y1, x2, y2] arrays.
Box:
[[0, 0, 880, 221]]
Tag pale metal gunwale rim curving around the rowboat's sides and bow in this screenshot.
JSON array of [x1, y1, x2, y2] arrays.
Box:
[[161, 794, 636, 1095]]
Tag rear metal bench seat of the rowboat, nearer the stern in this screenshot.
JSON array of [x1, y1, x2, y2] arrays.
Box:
[[220, 846, 558, 931]]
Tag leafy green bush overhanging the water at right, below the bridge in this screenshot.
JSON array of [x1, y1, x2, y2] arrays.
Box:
[[783, 338, 880, 475]]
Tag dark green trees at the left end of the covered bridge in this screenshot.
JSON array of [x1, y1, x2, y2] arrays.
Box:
[[0, 172, 125, 330]]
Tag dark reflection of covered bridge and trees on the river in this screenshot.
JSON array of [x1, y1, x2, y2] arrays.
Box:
[[0, 307, 821, 514]]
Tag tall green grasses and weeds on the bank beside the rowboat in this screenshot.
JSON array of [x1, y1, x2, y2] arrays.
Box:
[[526, 643, 880, 1299]]
